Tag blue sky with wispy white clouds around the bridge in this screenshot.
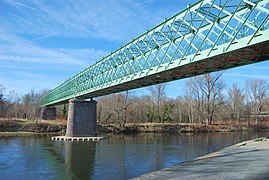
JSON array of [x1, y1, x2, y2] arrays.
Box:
[[0, 0, 269, 97]]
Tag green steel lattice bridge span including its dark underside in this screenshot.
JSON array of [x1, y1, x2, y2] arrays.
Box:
[[41, 0, 269, 106]]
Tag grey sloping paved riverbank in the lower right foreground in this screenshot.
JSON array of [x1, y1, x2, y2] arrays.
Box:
[[134, 138, 269, 180]]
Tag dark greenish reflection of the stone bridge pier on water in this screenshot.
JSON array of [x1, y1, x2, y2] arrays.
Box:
[[33, 137, 96, 179]]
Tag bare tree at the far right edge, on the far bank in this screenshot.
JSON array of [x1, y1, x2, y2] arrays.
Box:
[[245, 79, 269, 124]]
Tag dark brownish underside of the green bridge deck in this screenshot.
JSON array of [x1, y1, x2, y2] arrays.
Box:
[[50, 42, 269, 105]]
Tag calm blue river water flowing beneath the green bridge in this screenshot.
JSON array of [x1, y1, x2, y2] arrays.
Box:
[[0, 132, 269, 180]]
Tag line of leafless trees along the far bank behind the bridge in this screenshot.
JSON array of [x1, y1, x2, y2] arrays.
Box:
[[0, 72, 269, 125]]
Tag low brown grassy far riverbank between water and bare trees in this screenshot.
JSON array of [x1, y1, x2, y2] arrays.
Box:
[[0, 119, 269, 136]]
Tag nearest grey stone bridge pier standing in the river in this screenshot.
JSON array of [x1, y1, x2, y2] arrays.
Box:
[[65, 99, 97, 137]]
